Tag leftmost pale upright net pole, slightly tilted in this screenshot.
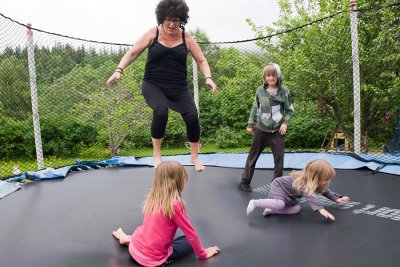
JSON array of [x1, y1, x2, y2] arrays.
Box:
[[26, 23, 44, 170]]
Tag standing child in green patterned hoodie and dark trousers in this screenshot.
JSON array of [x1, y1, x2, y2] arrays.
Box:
[[239, 63, 293, 192]]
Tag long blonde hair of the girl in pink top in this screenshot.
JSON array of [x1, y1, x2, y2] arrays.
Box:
[[143, 161, 188, 218]]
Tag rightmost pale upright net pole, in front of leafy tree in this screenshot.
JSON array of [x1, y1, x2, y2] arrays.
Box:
[[350, 0, 361, 154]]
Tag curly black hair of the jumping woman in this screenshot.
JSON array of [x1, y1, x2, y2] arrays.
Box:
[[156, 0, 189, 25]]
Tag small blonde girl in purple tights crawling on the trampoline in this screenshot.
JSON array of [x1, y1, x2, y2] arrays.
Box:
[[246, 159, 350, 221]]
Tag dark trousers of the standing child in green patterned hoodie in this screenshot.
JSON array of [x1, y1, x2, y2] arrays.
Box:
[[242, 128, 285, 184]]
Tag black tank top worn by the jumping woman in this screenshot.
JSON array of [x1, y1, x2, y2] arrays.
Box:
[[143, 27, 189, 95]]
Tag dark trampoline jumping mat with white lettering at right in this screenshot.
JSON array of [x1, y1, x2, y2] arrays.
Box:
[[0, 166, 400, 267]]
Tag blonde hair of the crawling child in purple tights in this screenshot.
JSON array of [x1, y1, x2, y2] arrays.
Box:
[[290, 159, 336, 195]]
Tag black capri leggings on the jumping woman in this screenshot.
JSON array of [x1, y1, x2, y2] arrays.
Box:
[[142, 81, 200, 143]]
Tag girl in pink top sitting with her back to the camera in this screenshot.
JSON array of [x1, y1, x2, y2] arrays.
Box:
[[112, 161, 219, 266]]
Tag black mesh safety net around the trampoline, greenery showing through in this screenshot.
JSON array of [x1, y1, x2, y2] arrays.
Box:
[[0, 1, 400, 178]]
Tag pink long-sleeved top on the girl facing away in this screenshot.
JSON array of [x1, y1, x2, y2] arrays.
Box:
[[129, 201, 207, 266]]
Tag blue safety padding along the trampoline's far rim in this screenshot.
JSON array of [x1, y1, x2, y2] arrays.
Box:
[[6, 153, 400, 182]]
